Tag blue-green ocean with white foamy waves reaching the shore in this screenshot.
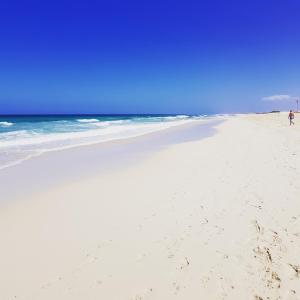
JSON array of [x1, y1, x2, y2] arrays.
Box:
[[0, 115, 208, 169]]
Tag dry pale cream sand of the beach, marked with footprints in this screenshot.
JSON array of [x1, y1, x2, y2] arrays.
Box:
[[0, 113, 300, 300]]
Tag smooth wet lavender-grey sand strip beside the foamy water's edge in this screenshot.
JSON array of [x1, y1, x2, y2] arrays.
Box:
[[0, 117, 224, 205]]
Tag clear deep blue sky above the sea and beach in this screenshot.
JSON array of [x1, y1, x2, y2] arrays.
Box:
[[0, 0, 300, 114]]
